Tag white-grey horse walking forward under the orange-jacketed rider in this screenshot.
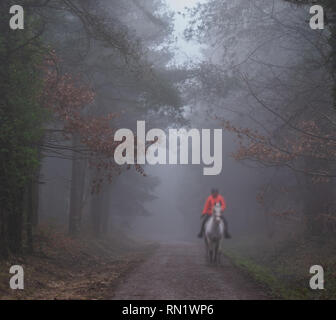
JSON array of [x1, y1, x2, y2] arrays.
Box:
[[204, 203, 224, 264]]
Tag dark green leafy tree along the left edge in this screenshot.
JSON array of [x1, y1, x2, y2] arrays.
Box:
[[0, 1, 45, 255]]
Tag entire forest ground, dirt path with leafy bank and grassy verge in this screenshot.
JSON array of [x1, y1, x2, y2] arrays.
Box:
[[0, 226, 336, 300]]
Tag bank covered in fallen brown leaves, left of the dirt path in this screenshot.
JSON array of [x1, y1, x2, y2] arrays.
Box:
[[0, 228, 154, 300]]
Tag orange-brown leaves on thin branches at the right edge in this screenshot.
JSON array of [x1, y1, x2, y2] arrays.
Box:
[[223, 120, 336, 182]]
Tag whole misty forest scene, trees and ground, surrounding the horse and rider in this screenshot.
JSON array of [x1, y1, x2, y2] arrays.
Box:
[[0, 0, 336, 299]]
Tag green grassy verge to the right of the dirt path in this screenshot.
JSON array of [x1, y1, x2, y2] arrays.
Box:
[[224, 237, 336, 300]]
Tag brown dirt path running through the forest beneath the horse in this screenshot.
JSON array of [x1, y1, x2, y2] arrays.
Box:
[[112, 243, 270, 300]]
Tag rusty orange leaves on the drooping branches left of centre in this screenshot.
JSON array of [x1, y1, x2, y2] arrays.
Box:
[[41, 52, 144, 192]]
